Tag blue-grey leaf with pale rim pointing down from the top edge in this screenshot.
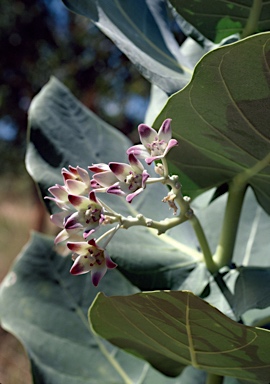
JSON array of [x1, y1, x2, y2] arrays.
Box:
[[63, 0, 192, 94]]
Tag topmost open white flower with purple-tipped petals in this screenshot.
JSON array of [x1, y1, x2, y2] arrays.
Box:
[[127, 119, 178, 164]]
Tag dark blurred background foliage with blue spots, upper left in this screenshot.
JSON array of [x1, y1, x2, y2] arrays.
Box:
[[0, 0, 150, 174]]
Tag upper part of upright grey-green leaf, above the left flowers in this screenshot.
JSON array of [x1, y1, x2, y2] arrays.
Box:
[[26, 77, 131, 212]]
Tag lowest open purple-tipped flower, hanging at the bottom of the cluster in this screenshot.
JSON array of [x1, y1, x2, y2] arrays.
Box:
[[67, 239, 117, 287]]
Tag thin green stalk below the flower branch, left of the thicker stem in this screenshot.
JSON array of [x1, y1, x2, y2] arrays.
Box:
[[190, 215, 218, 274]]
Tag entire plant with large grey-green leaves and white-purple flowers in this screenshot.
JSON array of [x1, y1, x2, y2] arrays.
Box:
[[0, 0, 270, 384]]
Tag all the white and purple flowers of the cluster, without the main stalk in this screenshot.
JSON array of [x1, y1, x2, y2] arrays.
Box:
[[45, 119, 178, 286]]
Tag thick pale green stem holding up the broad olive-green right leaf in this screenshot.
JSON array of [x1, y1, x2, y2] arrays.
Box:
[[214, 179, 247, 268]]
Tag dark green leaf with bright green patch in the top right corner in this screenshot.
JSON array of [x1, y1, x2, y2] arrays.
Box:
[[170, 0, 270, 43]]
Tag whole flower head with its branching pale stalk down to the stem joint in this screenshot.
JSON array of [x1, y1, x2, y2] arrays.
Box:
[[47, 119, 216, 286]]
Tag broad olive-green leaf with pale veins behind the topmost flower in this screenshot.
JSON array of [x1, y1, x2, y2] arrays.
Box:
[[155, 33, 270, 213]]
